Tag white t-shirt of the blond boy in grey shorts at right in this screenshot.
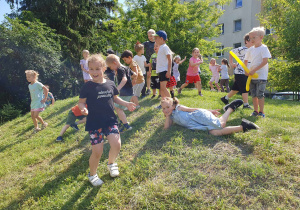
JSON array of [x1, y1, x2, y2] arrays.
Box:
[[245, 44, 271, 80]]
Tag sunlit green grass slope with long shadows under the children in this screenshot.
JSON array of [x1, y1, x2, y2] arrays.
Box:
[[0, 90, 300, 209]]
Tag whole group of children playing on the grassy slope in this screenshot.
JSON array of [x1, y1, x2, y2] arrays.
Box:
[[26, 25, 270, 186]]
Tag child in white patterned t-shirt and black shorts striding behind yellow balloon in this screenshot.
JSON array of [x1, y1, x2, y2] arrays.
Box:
[[221, 34, 253, 109]]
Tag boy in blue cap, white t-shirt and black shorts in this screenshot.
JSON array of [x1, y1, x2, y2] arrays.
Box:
[[154, 30, 172, 97]]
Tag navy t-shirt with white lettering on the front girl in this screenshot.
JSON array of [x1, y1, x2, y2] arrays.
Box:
[[79, 80, 119, 131]]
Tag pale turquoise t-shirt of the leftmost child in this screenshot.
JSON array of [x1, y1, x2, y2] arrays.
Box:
[[28, 82, 45, 109]]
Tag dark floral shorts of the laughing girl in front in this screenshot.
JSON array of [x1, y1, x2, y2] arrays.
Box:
[[89, 125, 119, 145]]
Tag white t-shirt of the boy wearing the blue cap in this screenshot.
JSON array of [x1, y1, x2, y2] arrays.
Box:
[[156, 44, 172, 73]]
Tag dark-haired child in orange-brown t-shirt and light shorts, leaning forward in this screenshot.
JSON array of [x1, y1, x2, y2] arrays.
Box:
[[121, 49, 146, 109]]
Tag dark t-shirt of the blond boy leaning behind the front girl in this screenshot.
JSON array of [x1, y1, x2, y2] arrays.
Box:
[[117, 65, 133, 96]]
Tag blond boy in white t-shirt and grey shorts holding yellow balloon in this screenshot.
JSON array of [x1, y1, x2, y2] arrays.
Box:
[[244, 27, 271, 117]]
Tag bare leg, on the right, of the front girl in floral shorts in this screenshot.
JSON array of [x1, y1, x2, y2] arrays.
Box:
[[107, 134, 121, 164]]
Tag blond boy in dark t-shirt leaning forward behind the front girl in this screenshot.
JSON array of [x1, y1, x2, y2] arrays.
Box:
[[106, 54, 137, 132]]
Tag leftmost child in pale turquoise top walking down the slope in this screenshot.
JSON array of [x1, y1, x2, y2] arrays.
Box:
[[25, 70, 48, 132]]
